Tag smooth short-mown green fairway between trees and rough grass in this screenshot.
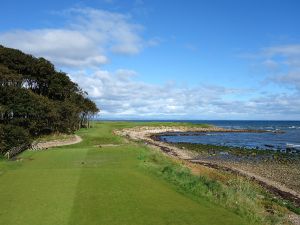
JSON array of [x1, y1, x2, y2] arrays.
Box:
[[0, 122, 247, 225]]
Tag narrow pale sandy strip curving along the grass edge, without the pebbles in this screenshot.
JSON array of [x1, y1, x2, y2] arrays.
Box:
[[115, 127, 300, 205]]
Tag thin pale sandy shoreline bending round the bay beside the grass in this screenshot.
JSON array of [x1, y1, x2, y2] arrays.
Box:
[[114, 126, 300, 207]]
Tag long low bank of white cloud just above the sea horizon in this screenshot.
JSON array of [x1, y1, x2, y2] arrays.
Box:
[[68, 70, 300, 119]]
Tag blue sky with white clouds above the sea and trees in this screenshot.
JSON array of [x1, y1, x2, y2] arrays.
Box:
[[0, 0, 300, 120]]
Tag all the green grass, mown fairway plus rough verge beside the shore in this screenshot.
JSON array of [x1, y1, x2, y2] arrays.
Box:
[[0, 122, 298, 225]]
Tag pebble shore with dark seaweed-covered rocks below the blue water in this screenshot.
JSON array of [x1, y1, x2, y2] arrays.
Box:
[[169, 143, 300, 198]]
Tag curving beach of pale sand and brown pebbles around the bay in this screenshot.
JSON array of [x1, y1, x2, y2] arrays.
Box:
[[115, 126, 300, 206]]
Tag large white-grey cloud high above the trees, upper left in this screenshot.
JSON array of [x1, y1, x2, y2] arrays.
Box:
[[0, 8, 146, 68]]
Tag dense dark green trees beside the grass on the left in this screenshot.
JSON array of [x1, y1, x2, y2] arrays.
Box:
[[0, 45, 99, 155]]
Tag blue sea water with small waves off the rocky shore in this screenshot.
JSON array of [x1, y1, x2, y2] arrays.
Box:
[[156, 120, 300, 151]]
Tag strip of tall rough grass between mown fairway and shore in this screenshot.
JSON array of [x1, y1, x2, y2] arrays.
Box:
[[140, 151, 287, 225]]
